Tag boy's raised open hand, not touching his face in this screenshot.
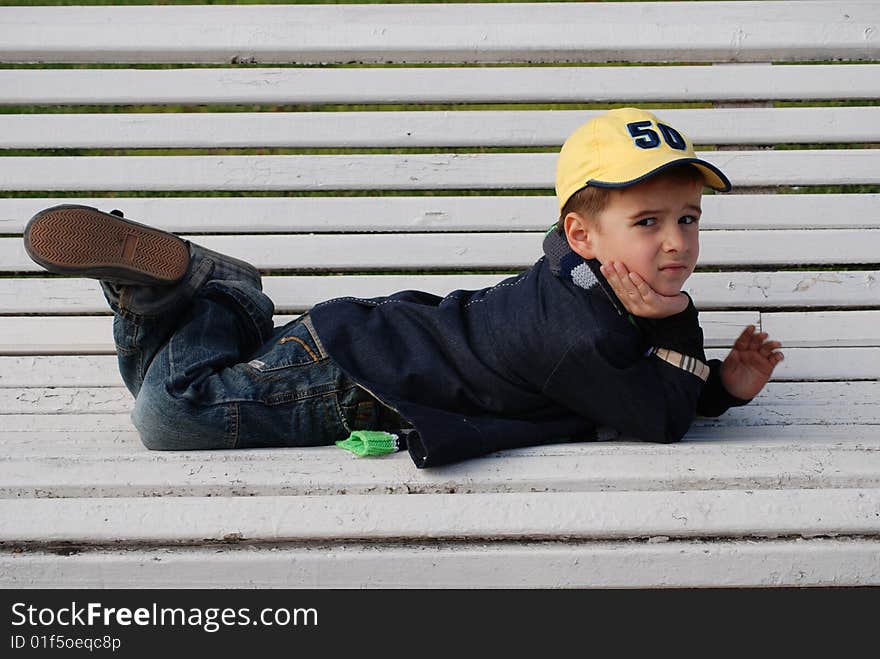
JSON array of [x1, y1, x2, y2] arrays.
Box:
[[721, 325, 785, 400]]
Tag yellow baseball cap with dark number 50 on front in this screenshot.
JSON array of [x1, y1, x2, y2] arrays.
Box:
[[556, 108, 730, 210]]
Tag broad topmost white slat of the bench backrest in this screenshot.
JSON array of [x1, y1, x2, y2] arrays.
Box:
[[0, 1, 880, 63]]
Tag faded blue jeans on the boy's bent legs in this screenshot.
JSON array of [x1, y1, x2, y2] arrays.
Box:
[[101, 243, 401, 450]]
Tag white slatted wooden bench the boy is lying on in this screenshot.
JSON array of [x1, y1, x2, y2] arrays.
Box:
[[0, 1, 880, 587]]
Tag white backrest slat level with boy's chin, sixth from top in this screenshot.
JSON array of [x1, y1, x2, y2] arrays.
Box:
[[6, 229, 880, 276]]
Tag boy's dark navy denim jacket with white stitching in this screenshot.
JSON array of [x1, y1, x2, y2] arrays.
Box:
[[310, 230, 749, 467]]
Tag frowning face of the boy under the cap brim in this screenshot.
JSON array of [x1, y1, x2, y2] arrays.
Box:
[[565, 174, 703, 295]]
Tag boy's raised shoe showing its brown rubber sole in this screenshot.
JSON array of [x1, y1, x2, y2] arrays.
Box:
[[24, 204, 189, 286]]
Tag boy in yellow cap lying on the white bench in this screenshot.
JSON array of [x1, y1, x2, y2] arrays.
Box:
[[24, 108, 783, 467]]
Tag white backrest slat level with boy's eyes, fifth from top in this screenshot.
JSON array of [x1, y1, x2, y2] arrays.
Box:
[[0, 193, 880, 233]]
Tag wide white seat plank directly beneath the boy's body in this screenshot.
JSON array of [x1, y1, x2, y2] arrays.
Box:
[[0, 420, 880, 499]]
